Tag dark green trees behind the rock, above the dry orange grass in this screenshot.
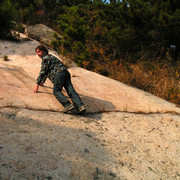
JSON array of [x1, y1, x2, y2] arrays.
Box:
[[0, 0, 180, 66]]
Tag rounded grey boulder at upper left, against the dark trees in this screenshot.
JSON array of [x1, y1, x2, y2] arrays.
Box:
[[25, 24, 62, 45]]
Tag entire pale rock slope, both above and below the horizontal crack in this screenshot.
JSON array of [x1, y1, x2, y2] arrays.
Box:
[[0, 34, 180, 180]]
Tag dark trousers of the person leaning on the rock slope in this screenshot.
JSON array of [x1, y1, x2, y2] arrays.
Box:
[[53, 70, 83, 109]]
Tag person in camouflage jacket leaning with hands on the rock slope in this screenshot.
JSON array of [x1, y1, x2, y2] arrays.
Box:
[[33, 45, 86, 114]]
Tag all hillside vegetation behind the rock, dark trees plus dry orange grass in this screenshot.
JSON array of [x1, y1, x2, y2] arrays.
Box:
[[0, 0, 180, 105]]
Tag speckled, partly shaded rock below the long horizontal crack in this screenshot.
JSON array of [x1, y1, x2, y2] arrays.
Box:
[[0, 108, 180, 180]]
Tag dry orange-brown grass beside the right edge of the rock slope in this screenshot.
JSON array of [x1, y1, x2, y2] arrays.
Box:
[[90, 60, 180, 106]]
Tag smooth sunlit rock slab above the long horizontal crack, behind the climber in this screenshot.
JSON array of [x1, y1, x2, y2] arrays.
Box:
[[0, 35, 180, 113]]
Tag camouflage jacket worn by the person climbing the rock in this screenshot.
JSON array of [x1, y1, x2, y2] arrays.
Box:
[[37, 54, 66, 84]]
